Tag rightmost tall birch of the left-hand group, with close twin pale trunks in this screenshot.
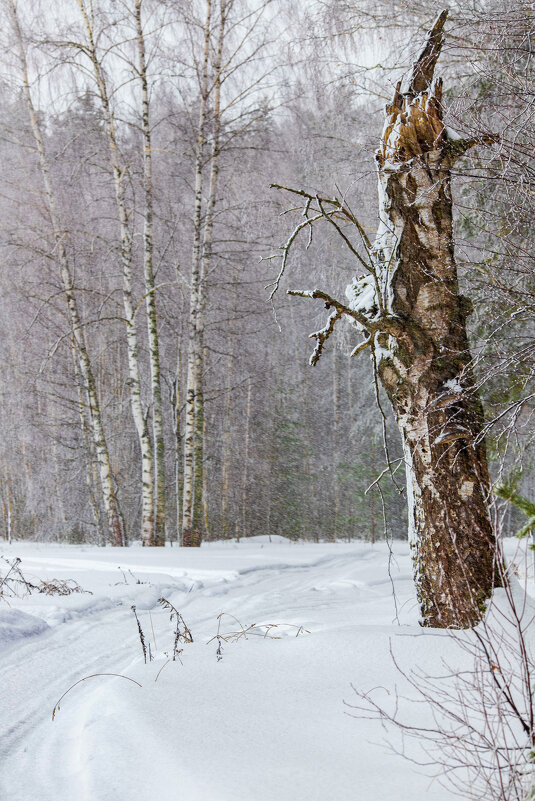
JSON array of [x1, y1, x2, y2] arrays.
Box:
[[182, 0, 278, 545]]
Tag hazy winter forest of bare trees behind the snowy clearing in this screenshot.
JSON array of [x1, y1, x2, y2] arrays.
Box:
[[0, 0, 535, 544]]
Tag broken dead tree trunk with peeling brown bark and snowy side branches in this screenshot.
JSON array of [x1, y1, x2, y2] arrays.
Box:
[[274, 11, 500, 628]]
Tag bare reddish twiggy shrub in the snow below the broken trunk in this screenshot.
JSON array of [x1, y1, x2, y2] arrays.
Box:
[[347, 576, 535, 801]]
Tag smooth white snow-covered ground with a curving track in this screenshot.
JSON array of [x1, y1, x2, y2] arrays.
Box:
[[0, 538, 532, 801]]
